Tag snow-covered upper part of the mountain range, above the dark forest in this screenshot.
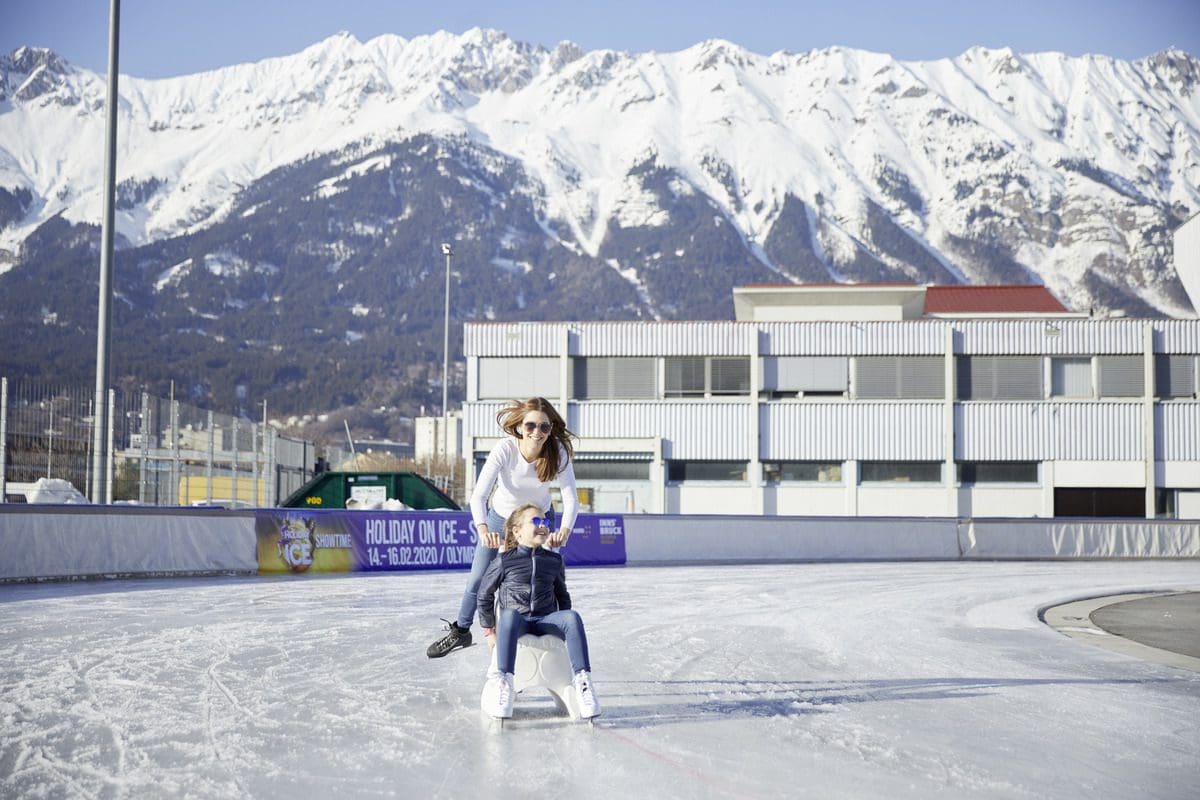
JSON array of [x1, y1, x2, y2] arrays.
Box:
[[0, 29, 1200, 314]]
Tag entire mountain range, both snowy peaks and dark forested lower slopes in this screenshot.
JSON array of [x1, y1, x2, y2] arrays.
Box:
[[0, 30, 1200, 427]]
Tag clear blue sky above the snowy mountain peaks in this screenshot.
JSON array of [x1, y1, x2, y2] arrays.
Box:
[[0, 0, 1200, 78]]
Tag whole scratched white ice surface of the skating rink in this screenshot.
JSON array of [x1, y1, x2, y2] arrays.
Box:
[[0, 561, 1200, 800]]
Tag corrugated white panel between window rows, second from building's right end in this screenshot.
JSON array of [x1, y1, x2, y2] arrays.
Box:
[[954, 402, 1144, 461]]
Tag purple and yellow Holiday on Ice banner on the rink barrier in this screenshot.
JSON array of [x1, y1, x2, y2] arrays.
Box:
[[254, 509, 625, 575]]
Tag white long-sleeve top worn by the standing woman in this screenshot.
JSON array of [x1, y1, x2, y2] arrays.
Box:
[[470, 437, 580, 534]]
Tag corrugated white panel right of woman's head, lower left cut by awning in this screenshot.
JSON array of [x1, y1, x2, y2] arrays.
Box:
[[568, 401, 754, 461]]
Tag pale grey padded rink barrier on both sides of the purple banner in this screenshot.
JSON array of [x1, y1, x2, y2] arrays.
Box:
[[0, 504, 1200, 582]]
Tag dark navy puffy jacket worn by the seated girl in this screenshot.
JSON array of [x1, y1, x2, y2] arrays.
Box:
[[479, 546, 571, 627]]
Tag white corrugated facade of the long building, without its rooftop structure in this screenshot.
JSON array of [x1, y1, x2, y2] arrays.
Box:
[[463, 290, 1200, 518]]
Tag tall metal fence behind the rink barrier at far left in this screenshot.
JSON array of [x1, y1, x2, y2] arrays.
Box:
[[0, 378, 319, 507]]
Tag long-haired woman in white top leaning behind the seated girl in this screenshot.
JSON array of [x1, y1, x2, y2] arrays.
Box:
[[425, 397, 578, 658]]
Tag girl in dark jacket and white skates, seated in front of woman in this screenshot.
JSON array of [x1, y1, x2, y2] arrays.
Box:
[[479, 503, 600, 720]]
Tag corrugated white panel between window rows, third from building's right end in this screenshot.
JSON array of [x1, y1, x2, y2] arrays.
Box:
[[760, 402, 944, 461]]
